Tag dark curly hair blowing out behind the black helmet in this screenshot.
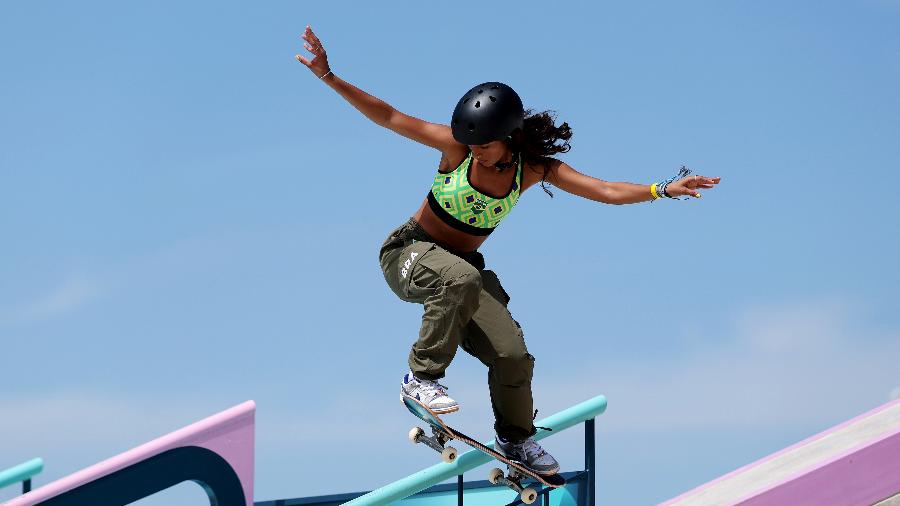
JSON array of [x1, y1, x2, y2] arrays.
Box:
[[506, 109, 572, 197]]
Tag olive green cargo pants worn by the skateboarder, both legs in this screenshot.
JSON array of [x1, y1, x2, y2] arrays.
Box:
[[380, 220, 535, 441]]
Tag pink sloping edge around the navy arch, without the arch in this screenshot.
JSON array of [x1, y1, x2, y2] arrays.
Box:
[[5, 401, 256, 506]]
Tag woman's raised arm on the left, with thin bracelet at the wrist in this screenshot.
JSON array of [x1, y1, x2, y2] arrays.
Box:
[[297, 26, 461, 153]]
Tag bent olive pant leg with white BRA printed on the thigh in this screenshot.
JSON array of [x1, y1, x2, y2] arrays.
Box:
[[381, 241, 481, 380]]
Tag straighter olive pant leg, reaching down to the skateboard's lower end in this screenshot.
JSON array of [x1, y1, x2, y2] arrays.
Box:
[[461, 270, 535, 441]]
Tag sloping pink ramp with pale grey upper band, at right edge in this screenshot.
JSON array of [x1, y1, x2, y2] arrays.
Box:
[[662, 399, 900, 506]]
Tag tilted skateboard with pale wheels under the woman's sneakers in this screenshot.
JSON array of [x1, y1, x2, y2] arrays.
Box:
[[402, 395, 566, 504]]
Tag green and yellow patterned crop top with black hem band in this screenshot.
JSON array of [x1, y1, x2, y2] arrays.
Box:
[[428, 151, 522, 235]]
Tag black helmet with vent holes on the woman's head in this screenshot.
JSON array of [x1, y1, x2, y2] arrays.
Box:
[[450, 82, 525, 146]]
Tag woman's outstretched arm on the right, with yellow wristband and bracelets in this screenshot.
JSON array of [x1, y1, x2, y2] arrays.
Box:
[[546, 160, 721, 205]]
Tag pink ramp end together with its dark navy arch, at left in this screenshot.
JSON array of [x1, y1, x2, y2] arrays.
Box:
[[4, 401, 256, 506]]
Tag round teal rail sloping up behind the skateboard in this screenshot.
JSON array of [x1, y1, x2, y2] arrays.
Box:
[[344, 395, 606, 506]]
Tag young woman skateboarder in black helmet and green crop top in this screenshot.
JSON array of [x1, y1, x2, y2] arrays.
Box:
[[297, 26, 719, 474]]
